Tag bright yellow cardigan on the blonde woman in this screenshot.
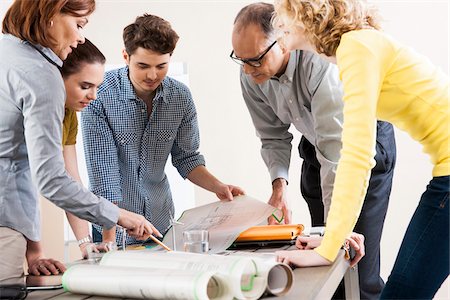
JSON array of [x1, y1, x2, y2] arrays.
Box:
[[316, 29, 450, 261]]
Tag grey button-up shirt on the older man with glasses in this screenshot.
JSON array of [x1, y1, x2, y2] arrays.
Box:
[[241, 50, 344, 213]]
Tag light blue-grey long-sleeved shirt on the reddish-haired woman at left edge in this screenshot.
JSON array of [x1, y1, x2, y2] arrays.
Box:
[[0, 35, 119, 241]]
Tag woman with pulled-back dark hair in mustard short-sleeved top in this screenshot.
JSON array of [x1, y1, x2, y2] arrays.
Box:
[[27, 39, 109, 275]]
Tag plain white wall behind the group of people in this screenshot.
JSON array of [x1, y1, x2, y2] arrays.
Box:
[[0, 0, 450, 299]]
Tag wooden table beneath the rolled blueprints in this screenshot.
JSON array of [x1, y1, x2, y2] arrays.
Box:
[[27, 250, 360, 300]]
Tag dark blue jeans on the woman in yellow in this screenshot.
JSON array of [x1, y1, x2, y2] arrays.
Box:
[[381, 176, 450, 299]]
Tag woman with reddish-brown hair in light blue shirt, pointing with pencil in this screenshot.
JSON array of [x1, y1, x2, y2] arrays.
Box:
[[0, 0, 159, 280]]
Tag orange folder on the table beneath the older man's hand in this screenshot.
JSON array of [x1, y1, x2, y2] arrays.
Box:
[[236, 224, 304, 242]]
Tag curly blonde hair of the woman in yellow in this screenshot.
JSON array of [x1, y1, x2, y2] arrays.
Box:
[[274, 0, 381, 56]]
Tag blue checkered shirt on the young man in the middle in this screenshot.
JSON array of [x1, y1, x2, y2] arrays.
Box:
[[81, 67, 205, 243]]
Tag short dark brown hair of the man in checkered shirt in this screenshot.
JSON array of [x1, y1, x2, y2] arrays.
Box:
[[123, 14, 179, 55]]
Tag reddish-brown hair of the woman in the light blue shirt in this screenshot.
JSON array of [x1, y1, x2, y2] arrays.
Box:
[[2, 0, 95, 47]]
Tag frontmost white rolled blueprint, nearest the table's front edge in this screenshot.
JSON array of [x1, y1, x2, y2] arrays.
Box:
[[62, 264, 227, 300]]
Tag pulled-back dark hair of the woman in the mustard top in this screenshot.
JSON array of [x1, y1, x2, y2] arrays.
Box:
[[61, 39, 106, 78]]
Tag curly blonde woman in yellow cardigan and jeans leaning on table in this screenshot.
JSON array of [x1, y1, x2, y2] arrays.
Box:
[[275, 0, 450, 299]]
